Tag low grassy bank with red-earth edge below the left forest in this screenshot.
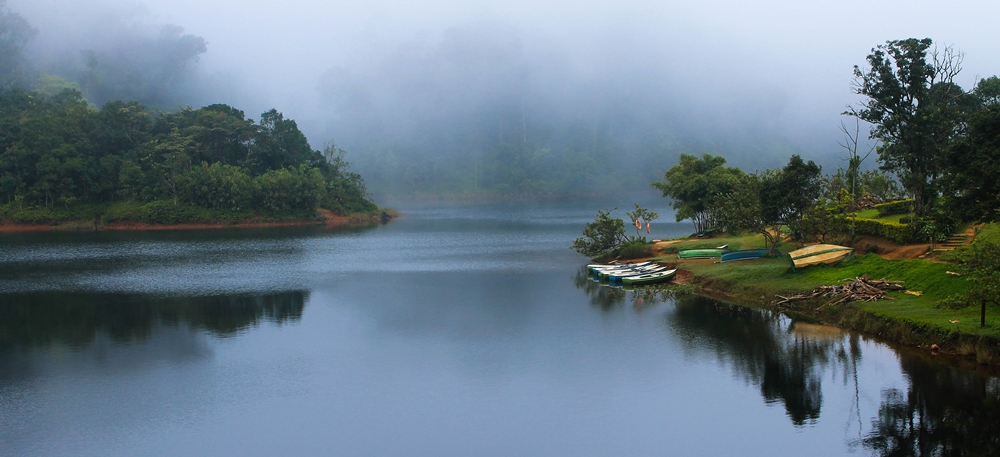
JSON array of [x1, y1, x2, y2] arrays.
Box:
[[0, 200, 394, 229]]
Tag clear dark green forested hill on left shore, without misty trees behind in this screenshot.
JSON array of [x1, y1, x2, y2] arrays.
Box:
[[0, 90, 376, 222]]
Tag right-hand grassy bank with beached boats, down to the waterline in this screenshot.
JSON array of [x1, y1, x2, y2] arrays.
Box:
[[656, 230, 1000, 363]]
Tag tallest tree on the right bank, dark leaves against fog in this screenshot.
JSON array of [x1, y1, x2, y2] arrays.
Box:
[[844, 38, 969, 216]]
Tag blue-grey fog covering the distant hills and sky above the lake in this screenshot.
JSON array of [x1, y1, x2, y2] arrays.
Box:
[[9, 0, 1000, 198]]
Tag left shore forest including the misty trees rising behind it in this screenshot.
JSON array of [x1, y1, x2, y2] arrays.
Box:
[[0, 0, 376, 223]]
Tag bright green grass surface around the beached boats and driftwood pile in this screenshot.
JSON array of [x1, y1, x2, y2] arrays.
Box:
[[658, 233, 1000, 339]]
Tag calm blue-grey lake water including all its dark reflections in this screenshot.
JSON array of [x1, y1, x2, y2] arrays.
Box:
[[0, 201, 1000, 456]]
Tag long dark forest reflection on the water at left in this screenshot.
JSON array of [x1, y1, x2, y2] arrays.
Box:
[[0, 291, 308, 353]]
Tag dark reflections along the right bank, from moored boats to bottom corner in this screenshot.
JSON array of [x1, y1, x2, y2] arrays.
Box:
[[574, 270, 1000, 456]]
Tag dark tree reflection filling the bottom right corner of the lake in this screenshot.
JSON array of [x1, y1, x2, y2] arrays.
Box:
[[854, 357, 1000, 456]]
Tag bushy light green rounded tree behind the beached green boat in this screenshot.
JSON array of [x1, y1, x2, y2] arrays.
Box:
[[651, 154, 744, 233]]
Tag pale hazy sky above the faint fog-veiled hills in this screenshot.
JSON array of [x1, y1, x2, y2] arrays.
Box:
[[10, 0, 1000, 163]]
